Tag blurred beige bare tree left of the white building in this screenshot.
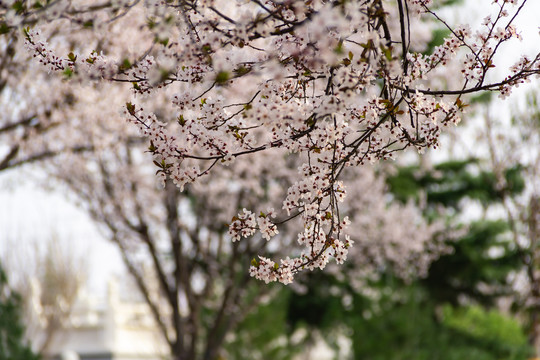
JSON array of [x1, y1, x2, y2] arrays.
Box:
[[0, 235, 88, 358]]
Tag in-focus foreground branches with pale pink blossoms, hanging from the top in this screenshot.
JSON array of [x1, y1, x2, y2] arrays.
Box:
[[21, 0, 540, 283]]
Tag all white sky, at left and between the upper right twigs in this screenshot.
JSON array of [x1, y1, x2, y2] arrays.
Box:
[[0, 0, 540, 294]]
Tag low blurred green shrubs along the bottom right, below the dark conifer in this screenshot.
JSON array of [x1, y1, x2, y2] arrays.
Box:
[[284, 273, 531, 360]]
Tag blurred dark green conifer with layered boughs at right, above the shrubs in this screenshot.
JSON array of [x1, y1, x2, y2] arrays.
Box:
[[388, 159, 525, 306]]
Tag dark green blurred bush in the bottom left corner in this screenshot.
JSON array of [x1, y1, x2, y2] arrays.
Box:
[[0, 264, 39, 360]]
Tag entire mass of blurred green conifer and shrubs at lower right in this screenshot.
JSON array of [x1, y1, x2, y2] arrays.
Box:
[[278, 159, 531, 360]]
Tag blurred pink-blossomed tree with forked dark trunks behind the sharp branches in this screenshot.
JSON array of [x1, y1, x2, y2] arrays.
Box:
[[0, 9, 438, 352]]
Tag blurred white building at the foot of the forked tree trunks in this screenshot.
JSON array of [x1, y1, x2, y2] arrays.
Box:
[[44, 280, 168, 360]]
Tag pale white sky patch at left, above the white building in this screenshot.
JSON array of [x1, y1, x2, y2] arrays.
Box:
[[0, 169, 124, 296]]
